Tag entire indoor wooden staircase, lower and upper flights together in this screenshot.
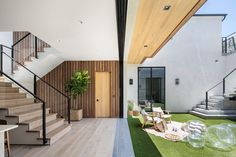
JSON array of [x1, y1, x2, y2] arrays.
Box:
[[0, 32, 71, 145]]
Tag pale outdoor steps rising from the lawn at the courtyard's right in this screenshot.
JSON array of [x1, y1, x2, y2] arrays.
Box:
[[190, 88, 236, 118]]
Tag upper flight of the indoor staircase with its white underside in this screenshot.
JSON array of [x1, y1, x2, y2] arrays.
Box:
[[9, 32, 64, 80]]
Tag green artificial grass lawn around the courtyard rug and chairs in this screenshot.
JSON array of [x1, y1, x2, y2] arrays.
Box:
[[128, 114, 236, 157]]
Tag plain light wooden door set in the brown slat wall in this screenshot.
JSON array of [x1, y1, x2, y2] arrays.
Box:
[[95, 72, 111, 117]]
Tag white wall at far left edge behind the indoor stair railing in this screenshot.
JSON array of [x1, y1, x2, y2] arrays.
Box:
[[0, 32, 13, 74]]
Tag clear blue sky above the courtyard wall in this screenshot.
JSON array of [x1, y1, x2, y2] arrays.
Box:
[[197, 0, 236, 37]]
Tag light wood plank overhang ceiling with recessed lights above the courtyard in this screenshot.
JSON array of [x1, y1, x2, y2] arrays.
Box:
[[128, 0, 206, 64]]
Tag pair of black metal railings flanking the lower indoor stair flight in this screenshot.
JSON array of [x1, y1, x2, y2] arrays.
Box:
[[0, 45, 71, 144]]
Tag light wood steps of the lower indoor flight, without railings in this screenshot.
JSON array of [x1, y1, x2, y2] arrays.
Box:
[[0, 77, 71, 145]]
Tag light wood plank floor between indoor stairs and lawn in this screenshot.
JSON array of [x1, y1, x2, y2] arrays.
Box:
[[11, 118, 117, 157]]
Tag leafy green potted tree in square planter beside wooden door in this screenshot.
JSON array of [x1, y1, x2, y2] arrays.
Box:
[[65, 70, 90, 120]]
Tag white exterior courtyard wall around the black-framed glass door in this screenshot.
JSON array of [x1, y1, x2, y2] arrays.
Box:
[[125, 16, 225, 112]]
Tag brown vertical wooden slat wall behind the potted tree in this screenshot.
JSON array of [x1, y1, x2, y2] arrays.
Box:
[[37, 61, 119, 118]]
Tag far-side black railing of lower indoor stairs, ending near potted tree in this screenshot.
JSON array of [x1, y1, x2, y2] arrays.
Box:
[[0, 44, 71, 124]]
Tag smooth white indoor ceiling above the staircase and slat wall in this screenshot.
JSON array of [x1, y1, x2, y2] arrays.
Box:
[[0, 0, 118, 60]]
